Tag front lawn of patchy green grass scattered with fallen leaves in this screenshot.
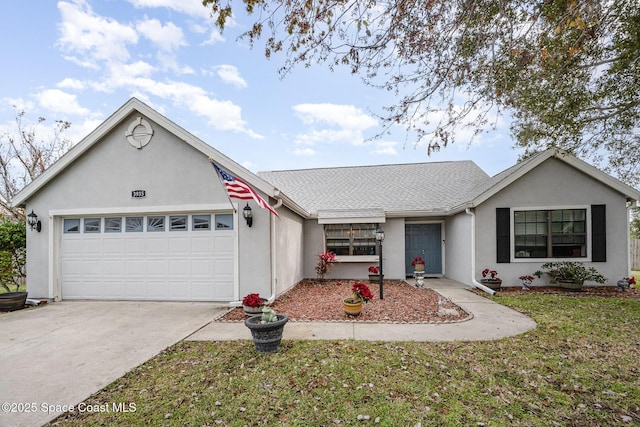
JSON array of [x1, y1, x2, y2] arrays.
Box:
[[47, 294, 640, 427]]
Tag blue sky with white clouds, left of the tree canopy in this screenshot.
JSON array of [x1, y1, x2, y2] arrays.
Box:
[[0, 0, 518, 175]]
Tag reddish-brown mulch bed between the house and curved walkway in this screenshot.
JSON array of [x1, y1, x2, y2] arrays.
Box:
[[218, 279, 471, 323]]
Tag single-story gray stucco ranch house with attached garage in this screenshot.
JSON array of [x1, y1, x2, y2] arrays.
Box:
[[13, 98, 640, 302]]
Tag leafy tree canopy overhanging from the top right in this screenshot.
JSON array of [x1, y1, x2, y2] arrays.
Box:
[[203, 0, 640, 184]]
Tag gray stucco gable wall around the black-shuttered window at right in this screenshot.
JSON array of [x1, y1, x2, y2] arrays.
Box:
[[475, 158, 629, 286]]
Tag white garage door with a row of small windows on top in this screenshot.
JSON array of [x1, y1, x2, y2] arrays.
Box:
[[60, 214, 235, 301]]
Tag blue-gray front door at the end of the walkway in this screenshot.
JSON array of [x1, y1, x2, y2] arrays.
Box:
[[404, 223, 442, 277]]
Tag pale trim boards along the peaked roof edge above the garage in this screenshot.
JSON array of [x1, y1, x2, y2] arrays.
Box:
[[12, 98, 290, 211]]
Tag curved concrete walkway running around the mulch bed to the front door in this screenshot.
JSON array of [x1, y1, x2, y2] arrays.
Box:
[[187, 279, 536, 342]]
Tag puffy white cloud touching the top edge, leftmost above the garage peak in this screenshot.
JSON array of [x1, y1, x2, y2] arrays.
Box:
[[58, 1, 138, 68]]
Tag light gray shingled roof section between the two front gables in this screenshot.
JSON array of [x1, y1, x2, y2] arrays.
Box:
[[258, 161, 490, 217]]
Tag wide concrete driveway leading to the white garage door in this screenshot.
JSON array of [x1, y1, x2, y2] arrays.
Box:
[[0, 301, 227, 426]]
